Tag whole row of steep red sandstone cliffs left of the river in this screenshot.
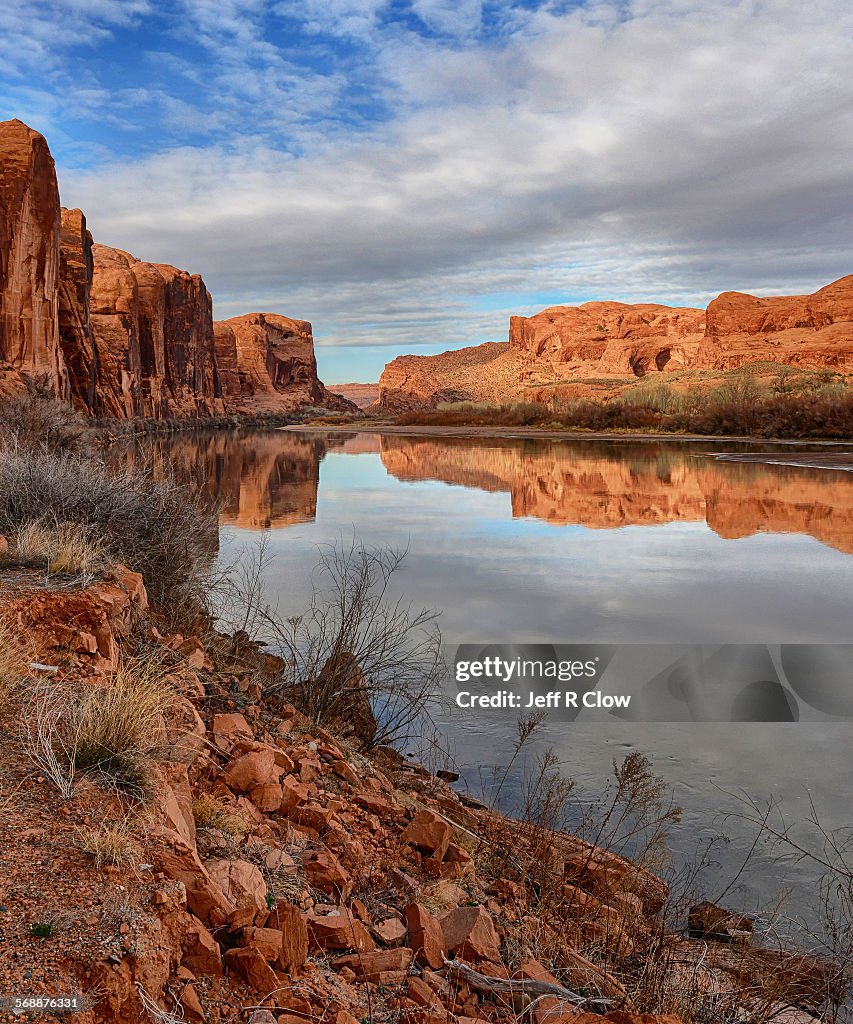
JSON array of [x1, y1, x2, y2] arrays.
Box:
[[0, 120, 354, 419]]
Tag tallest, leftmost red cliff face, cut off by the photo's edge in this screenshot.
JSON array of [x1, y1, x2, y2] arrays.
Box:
[[0, 120, 66, 394]]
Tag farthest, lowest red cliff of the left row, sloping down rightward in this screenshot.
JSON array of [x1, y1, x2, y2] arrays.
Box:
[[214, 313, 355, 413]]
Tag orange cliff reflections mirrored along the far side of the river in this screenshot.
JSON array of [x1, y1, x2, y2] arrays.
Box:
[[135, 431, 853, 553]]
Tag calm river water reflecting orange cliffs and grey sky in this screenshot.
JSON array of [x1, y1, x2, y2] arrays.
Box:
[[143, 431, 853, 933]]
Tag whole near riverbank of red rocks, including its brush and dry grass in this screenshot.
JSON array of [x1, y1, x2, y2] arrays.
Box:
[[0, 399, 846, 1024]]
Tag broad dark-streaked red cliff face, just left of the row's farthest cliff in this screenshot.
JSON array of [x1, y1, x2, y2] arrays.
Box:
[[90, 245, 223, 419]]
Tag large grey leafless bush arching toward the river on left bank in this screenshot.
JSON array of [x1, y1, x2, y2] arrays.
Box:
[[0, 450, 217, 614]]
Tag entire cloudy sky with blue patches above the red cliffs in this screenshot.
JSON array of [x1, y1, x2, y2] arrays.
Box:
[[0, 0, 853, 383]]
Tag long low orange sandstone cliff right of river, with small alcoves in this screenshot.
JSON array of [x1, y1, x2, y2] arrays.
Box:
[[376, 275, 853, 412]]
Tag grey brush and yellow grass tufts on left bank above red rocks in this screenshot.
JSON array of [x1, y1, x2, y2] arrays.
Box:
[[0, 393, 217, 620]]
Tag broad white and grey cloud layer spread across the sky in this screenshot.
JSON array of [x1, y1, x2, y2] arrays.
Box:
[[46, 0, 853, 360]]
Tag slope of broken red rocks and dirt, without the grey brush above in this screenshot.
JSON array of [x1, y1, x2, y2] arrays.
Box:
[[0, 557, 840, 1024]]
